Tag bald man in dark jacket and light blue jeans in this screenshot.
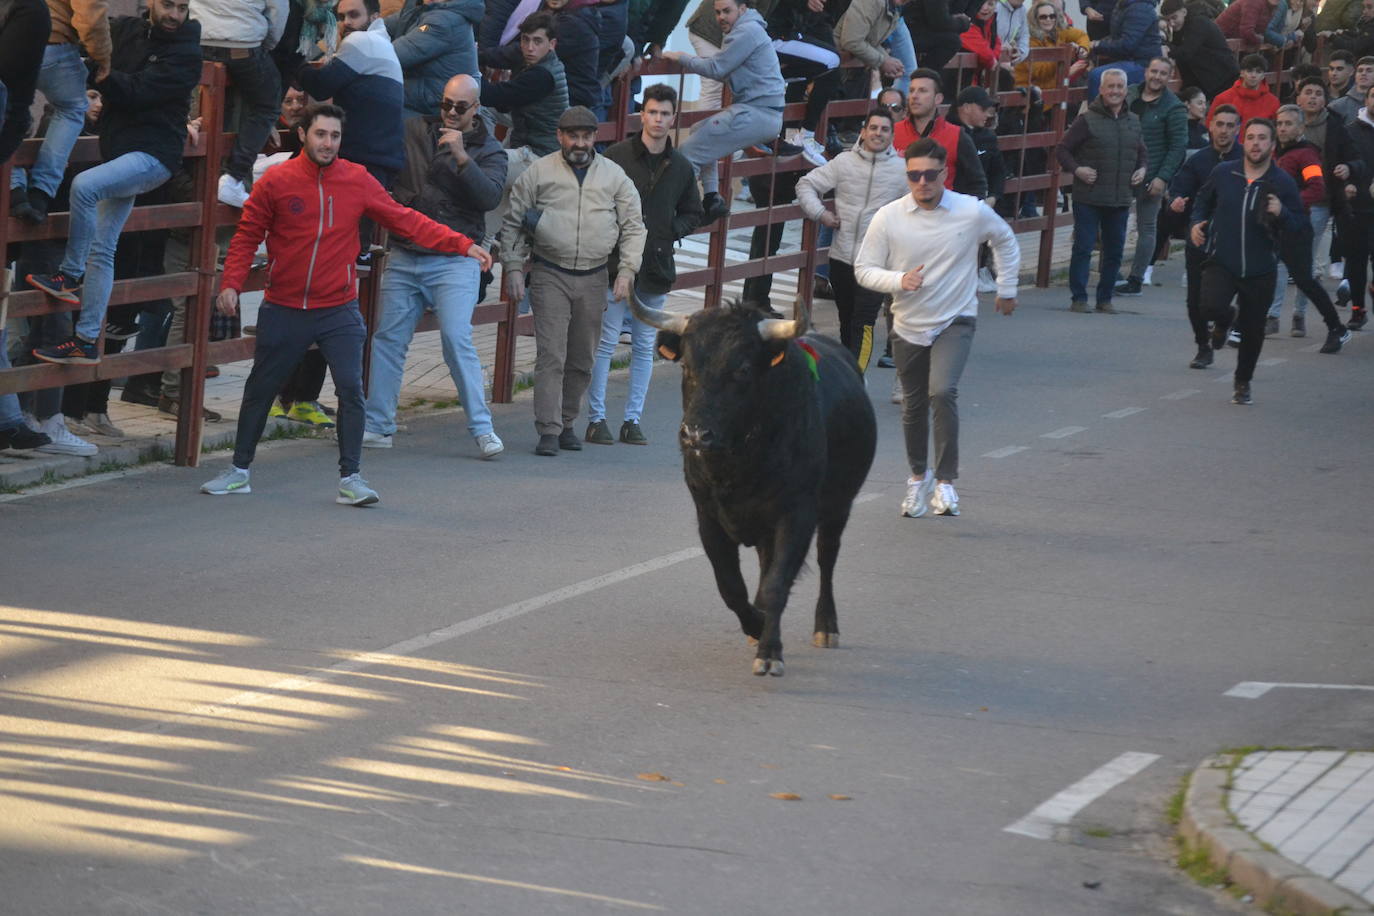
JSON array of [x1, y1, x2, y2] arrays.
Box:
[[363, 74, 506, 459]]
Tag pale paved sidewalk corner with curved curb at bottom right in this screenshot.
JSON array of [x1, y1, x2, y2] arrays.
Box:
[[1179, 750, 1374, 916]]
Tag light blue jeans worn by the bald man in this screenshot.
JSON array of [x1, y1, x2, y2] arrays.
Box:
[[364, 247, 492, 435]]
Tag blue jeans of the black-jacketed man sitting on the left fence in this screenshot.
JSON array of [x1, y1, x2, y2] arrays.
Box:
[[59, 152, 172, 341]]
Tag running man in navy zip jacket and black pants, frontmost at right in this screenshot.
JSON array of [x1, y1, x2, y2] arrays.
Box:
[[1190, 118, 1305, 404]]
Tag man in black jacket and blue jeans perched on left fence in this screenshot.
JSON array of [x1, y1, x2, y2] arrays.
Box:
[[29, 0, 201, 364]]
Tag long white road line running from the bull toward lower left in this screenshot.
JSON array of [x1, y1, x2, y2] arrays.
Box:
[[21, 547, 705, 766]]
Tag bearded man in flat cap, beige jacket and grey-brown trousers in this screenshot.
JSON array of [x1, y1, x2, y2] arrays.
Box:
[[500, 106, 644, 456]]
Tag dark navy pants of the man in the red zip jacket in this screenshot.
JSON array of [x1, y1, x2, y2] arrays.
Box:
[[234, 299, 367, 477]]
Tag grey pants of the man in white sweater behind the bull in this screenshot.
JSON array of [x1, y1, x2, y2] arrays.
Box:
[[892, 317, 977, 481]]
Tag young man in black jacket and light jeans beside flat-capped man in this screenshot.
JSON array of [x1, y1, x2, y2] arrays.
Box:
[[584, 84, 702, 445]]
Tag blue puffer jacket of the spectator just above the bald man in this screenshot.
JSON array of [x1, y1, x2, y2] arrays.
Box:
[[385, 0, 485, 115]]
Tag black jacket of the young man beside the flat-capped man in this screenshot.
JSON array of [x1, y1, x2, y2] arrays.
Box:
[[606, 133, 702, 294]]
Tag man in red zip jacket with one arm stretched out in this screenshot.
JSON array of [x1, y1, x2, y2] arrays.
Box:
[[201, 104, 492, 505]]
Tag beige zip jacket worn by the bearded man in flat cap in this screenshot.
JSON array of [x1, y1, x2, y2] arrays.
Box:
[[500, 151, 644, 280]]
